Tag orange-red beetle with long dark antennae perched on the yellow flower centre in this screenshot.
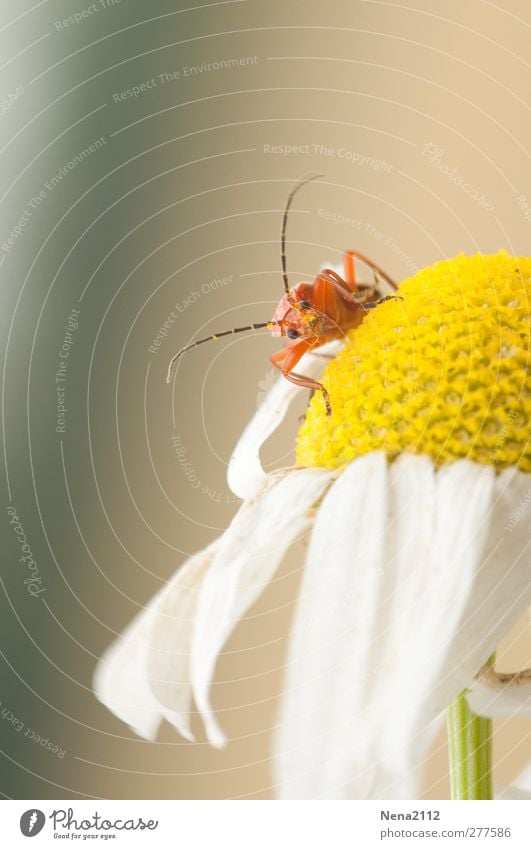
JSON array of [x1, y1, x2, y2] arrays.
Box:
[[167, 174, 398, 415]]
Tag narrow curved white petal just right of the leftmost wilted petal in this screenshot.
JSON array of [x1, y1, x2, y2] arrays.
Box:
[[192, 469, 333, 747]]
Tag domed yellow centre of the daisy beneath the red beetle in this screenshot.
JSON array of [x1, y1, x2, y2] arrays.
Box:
[[297, 252, 531, 472]]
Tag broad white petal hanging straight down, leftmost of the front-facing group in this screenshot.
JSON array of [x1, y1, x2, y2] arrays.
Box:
[[276, 454, 387, 799]]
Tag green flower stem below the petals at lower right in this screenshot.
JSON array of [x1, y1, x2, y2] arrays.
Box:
[[447, 657, 494, 799]]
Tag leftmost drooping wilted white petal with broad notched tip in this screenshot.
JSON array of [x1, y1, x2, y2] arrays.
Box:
[[93, 542, 218, 740]]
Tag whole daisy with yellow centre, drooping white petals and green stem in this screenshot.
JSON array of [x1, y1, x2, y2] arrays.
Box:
[[95, 252, 531, 799]]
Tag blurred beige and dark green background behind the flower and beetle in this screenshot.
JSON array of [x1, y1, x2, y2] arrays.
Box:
[[0, 0, 531, 799]]
